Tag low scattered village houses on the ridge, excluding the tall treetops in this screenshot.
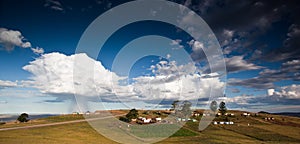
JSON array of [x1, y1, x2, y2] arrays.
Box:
[[72, 109, 275, 125]]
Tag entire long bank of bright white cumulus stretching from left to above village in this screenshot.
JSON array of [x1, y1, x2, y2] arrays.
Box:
[[23, 53, 225, 102]]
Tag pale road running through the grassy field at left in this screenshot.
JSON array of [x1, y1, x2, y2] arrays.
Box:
[[0, 114, 125, 131]]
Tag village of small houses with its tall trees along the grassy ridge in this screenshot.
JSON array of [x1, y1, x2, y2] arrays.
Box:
[[72, 101, 275, 126]]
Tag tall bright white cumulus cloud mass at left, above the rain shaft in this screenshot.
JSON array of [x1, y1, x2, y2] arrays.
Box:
[[23, 53, 119, 96]]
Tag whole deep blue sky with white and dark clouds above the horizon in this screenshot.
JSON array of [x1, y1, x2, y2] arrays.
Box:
[[0, 0, 300, 113]]
